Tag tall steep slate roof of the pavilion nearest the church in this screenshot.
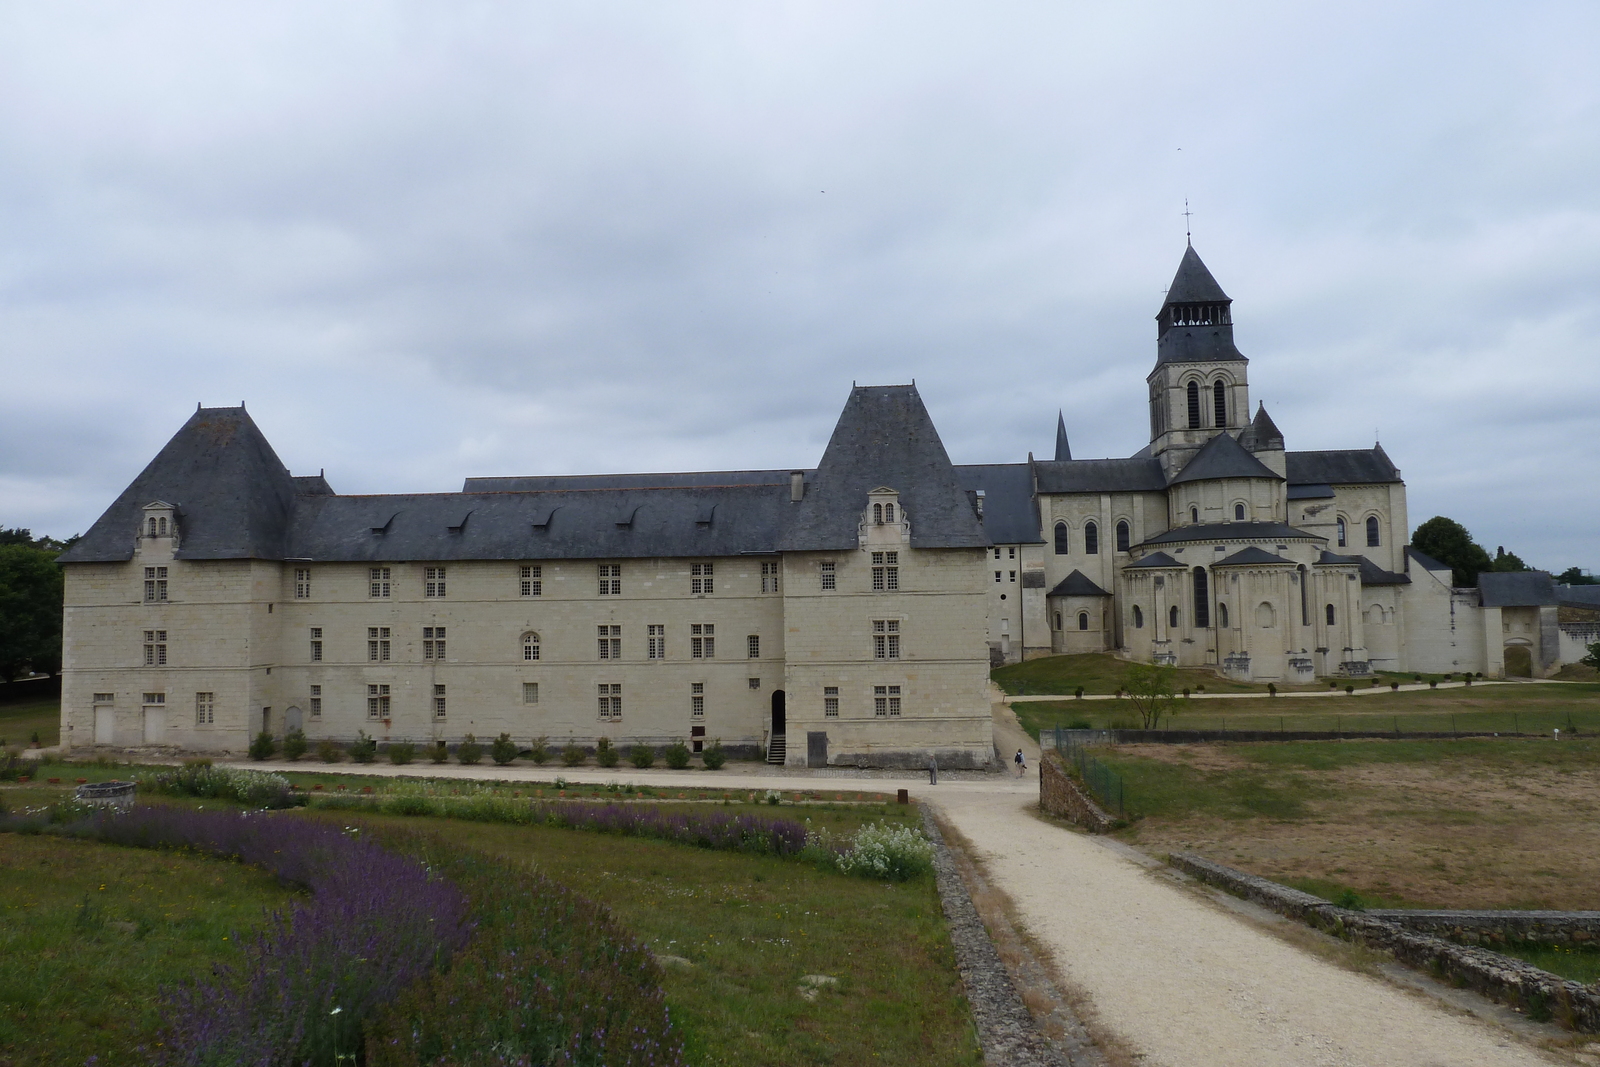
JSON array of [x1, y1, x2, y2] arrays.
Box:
[[779, 386, 990, 552]]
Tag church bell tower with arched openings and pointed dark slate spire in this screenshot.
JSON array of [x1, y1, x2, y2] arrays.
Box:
[[1146, 245, 1250, 478]]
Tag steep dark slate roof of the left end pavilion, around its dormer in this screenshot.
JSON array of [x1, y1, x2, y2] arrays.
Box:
[[59, 406, 296, 563]]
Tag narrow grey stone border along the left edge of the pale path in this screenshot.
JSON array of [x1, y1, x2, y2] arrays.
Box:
[[920, 805, 1072, 1067]]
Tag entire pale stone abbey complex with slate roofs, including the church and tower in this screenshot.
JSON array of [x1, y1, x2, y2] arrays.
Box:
[[61, 248, 1560, 766]]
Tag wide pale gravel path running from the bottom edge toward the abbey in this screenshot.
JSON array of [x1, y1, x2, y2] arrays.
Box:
[[926, 776, 1555, 1067]]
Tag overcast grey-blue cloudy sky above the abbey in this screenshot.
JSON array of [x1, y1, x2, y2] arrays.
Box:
[[0, 0, 1600, 569]]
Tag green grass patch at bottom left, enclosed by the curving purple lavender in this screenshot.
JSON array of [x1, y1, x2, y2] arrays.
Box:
[[0, 833, 290, 1067]]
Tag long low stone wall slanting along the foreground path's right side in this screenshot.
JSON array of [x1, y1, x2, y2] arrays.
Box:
[[1168, 853, 1600, 1033]]
